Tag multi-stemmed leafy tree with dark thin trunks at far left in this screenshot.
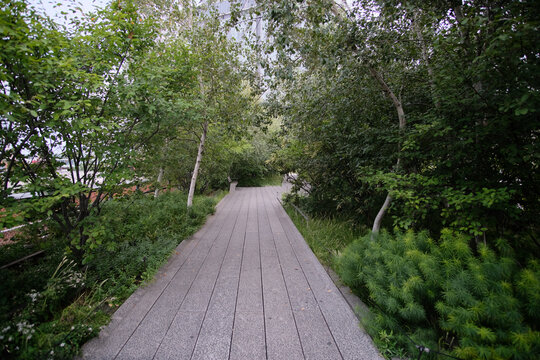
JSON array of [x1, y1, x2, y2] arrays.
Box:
[[0, 1, 155, 236]]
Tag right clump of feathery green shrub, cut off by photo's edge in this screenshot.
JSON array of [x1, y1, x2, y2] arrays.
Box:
[[436, 233, 540, 359]]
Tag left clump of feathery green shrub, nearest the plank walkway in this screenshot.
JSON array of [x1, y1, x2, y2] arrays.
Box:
[[338, 231, 441, 354]]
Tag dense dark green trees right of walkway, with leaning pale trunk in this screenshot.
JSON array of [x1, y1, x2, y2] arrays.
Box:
[[260, 0, 540, 242]]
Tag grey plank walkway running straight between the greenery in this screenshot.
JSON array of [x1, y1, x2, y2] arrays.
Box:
[[82, 187, 382, 360]]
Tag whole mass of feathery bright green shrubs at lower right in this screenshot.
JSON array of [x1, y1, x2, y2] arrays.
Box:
[[338, 230, 540, 359]]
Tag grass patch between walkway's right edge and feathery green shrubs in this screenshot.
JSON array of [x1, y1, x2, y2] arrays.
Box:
[[285, 205, 366, 270]]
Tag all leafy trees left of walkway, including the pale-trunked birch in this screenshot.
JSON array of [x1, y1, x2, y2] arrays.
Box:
[[0, 0, 258, 260]]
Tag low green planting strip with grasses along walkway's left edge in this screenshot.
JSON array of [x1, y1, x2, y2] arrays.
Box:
[[0, 192, 219, 359]]
